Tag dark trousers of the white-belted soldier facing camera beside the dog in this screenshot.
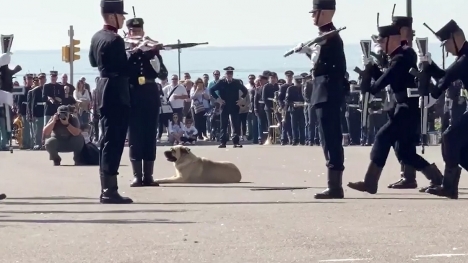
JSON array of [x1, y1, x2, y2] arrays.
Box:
[[128, 83, 160, 162]]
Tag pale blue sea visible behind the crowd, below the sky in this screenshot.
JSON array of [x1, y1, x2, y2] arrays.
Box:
[[10, 43, 453, 87]]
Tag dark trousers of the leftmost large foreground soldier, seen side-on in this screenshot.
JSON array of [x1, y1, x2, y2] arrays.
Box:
[[99, 106, 130, 177]]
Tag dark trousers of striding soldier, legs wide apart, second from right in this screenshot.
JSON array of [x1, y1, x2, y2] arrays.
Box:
[[371, 104, 429, 171]]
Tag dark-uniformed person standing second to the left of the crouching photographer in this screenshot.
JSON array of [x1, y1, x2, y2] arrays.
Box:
[[16, 74, 34, 150]]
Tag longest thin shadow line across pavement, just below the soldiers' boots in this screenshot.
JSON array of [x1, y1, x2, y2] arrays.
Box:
[[1, 202, 342, 205]]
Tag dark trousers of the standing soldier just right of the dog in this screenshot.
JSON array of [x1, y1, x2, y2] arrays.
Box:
[[315, 102, 344, 171]]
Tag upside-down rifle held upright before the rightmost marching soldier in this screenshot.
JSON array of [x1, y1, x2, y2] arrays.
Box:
[[409, 37, 431, 154]]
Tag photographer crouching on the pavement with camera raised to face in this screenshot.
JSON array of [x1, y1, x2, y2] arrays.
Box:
[[43, 105, 85, 166]]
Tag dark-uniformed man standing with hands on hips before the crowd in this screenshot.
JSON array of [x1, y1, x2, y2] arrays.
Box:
[[210, 67, 249, 148]]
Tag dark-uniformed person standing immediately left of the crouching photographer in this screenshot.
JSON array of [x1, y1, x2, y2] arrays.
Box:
[[30, 73, 46, 150]]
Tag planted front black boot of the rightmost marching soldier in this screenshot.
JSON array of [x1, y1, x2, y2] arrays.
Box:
[[426, 166, 461, 199]]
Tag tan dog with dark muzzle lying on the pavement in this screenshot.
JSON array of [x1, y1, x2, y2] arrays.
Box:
[[155, 145, 242, 184]]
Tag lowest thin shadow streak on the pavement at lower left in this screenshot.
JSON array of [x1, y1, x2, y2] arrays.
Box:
[[0, 219, 196, 225]]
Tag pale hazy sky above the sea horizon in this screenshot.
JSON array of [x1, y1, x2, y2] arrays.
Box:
[[0, 0, 468, 51]]
